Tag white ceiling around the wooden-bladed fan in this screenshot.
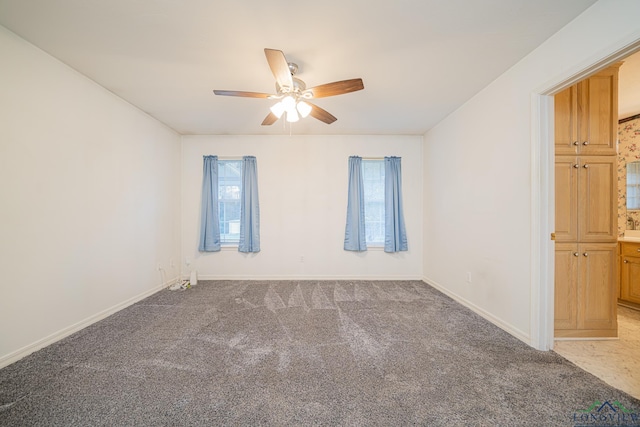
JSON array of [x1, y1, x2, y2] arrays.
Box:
[[0, 0, 595, 135]]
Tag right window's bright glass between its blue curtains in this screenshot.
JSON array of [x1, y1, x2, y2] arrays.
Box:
[[362, 160, 385, 246]]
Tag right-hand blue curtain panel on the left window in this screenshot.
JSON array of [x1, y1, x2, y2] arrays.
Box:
[[238, 156, 260, 252]]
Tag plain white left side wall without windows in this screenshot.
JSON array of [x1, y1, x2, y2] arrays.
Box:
[[0, 27, 180, 367]]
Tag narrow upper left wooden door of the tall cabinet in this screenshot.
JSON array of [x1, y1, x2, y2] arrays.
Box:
[[554, 84, 579, 155]]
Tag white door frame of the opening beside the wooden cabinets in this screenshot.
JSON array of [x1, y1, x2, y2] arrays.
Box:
[[529, 36, 640, 350]]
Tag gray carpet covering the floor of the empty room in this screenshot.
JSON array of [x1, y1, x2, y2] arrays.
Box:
[[0, 281, 640, 426]]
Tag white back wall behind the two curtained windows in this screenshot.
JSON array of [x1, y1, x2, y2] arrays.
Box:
[[182, 135, 422, 279]]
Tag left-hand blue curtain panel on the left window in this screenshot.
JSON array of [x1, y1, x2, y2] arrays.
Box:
[[198, 156, 220, 252]]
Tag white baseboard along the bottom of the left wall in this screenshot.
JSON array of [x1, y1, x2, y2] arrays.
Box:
[[0, 277, 178, 369]]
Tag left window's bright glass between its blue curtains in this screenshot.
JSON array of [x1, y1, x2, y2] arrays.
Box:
[[218, 160, 242, 244]]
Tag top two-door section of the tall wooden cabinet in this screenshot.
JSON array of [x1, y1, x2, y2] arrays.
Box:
[[554, 64, 620, 155]]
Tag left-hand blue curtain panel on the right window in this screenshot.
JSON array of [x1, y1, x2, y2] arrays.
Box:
[[344, 156, 367, 251]]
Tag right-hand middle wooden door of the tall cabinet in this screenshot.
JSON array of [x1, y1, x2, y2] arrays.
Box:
[[576, 156, 618, 242]]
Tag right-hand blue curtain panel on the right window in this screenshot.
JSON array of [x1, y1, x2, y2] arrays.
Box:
[[384, 157, 407, 252]]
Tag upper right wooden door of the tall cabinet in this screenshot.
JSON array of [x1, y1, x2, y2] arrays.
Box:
[[578, 67, 618, 155]]
